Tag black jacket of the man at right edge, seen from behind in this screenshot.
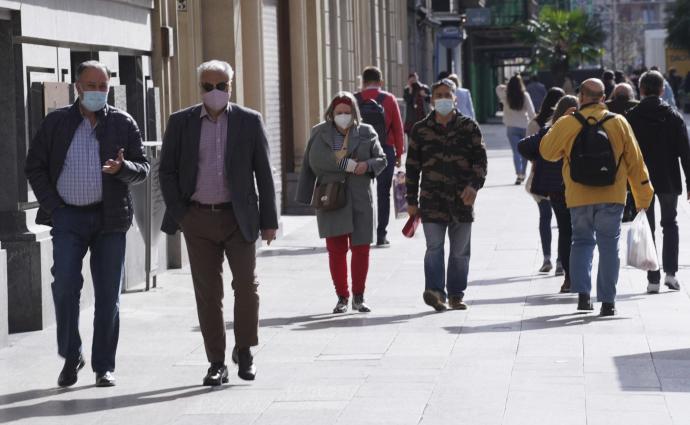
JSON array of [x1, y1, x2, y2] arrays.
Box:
[[626, 96, 690, 195]]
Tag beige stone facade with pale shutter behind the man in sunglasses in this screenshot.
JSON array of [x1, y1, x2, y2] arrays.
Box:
[[153, 0, 408, 213]]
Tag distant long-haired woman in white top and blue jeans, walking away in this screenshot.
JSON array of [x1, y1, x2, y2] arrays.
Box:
[[496, 75, 536, 185]]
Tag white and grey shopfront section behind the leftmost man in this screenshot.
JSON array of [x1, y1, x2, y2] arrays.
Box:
[[0, 0, 168, 344]]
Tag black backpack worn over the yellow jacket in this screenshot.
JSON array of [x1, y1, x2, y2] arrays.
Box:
[[570, 112, 623, 186]]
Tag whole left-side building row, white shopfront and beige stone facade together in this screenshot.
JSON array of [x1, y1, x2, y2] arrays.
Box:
[[0, 0, 414, 345]]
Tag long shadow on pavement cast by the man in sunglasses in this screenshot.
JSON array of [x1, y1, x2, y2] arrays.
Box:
[[0, 385, 224, 423]]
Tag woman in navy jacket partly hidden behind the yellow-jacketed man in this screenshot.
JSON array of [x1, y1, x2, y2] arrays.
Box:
[[518, 93, 577, 293]]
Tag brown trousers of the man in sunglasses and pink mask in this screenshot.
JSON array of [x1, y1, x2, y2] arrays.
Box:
[[181, 206, 259, 363]]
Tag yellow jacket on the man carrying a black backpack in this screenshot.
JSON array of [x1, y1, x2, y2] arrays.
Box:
[[539, 103, 654, 208]]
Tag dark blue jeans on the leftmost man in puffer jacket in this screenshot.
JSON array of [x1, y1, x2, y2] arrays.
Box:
[[50, 206, 126, 373]]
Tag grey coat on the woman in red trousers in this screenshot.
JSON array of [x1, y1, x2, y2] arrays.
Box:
[[295, 122, 386, 245]]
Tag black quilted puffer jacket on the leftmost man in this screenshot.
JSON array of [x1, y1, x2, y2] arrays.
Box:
[[24, 101, 149, 232]]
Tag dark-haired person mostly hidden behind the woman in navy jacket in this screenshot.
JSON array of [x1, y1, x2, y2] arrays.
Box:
[[518, 87, 565, 274]]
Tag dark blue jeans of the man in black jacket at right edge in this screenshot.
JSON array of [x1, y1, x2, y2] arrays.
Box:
[[647, 193, 678, 283]]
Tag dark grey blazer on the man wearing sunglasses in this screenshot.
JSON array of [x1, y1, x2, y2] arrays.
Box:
[[159, 103, 278, 242]]
